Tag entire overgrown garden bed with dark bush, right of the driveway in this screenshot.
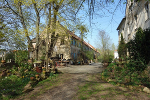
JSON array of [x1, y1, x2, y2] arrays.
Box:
[[101, 28, 150, 93]]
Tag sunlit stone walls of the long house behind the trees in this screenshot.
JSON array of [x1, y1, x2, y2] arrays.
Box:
[[30, 23, 99, 60]]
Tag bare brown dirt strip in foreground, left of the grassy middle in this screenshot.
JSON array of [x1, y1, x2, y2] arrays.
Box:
[[33, 74, 86, 100]]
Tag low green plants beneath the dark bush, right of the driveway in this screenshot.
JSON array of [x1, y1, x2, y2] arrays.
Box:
[[101, 61, 150, 85]]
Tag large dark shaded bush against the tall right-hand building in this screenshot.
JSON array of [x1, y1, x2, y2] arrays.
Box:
[[127, 28, 150, 64]]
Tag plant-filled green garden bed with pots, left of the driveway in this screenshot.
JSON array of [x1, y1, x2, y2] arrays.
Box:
[[0, 50, 56, 100]]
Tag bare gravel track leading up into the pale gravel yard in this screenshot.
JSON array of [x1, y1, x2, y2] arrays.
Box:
[[34, 63, 104, 100]]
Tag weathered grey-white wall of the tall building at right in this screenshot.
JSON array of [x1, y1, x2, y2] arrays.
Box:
[[118, 0, 150, 42]]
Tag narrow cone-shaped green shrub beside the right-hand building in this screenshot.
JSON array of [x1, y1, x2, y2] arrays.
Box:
[[118, 34, 127, 58]]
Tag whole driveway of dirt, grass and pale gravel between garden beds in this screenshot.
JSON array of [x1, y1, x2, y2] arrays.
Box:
[[12, 63, 150, 100]]
